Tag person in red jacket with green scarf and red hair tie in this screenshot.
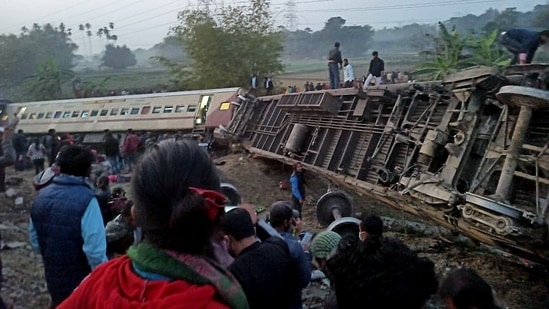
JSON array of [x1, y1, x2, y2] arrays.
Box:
[[58, 141, 249, 309]]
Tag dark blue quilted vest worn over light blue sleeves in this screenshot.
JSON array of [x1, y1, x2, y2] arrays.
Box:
[[31, 175, 94, 304]]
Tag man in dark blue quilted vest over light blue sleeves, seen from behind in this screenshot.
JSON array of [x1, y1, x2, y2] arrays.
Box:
[[29, 145, 107, 308]]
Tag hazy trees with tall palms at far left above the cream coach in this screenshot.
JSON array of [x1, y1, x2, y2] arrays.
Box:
[[0, 23, 137, 100]]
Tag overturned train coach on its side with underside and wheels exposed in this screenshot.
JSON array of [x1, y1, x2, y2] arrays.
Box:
[[215, 65, 549, 264]]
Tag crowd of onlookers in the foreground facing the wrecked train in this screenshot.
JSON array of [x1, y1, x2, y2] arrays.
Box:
[[0, 130, 506, 309]]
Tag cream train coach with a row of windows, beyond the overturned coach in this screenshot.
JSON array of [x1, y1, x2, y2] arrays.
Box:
[[0, 87, 240, 143]]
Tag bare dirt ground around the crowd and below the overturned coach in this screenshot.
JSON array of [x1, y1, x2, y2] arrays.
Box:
[[0, 154, 549, 308]]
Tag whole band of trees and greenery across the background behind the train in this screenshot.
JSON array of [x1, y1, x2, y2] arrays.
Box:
[[0, 0, 549, 100]]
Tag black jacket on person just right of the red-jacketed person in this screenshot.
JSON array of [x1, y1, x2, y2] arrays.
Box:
[[229, 237, 296, 309]]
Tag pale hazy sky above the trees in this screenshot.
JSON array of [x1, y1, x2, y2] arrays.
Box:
[[0, 0, 547, 53]]
